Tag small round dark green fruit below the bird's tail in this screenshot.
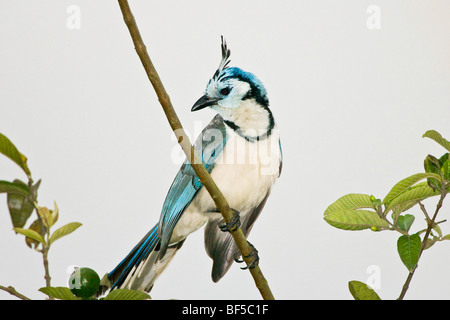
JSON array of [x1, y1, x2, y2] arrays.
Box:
[[69, 267, 100, 299]]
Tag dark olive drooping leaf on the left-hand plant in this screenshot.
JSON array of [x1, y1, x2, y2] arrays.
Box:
[[3, 179, 34, 228]]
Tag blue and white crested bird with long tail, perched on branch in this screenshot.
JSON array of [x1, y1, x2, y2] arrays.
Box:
[[102, 36, 283, 292]]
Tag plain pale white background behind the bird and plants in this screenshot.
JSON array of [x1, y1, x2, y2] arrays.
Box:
[[0, 0, 450, 299]]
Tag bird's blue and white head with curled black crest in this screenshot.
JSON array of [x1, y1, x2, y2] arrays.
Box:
[[191, 37, 269, 119]]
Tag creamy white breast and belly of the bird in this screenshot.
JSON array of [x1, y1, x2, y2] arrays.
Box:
[[170, 127, 281, 243]]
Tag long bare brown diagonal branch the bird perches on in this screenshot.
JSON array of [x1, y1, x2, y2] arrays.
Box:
[[118, 0, 274, 300]]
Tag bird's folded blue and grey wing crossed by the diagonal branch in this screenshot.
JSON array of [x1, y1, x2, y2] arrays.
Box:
[[158, 115, 227, 257]]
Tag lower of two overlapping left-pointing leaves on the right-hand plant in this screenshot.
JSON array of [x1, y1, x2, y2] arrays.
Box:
[[324, 209, 389, 231]]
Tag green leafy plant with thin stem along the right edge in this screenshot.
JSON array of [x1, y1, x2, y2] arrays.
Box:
[[324, 130, 450, 299]]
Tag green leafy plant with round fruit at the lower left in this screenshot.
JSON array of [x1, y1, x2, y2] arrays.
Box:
[[0, 133, 150, 300]]
